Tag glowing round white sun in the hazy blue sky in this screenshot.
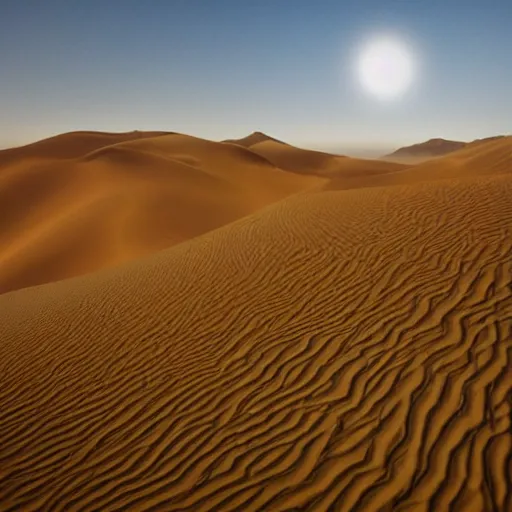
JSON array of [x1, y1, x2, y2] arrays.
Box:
[[358, 37, 414, 99]]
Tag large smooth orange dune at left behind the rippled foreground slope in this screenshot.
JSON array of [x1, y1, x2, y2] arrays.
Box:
[[0, 134, 321, 293]]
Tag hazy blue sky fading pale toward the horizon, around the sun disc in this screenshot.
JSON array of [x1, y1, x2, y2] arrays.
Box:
[[0, 0, 512, 153]]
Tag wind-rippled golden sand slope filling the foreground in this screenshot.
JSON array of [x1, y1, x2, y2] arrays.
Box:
[[0, 170, 512, 512]]
